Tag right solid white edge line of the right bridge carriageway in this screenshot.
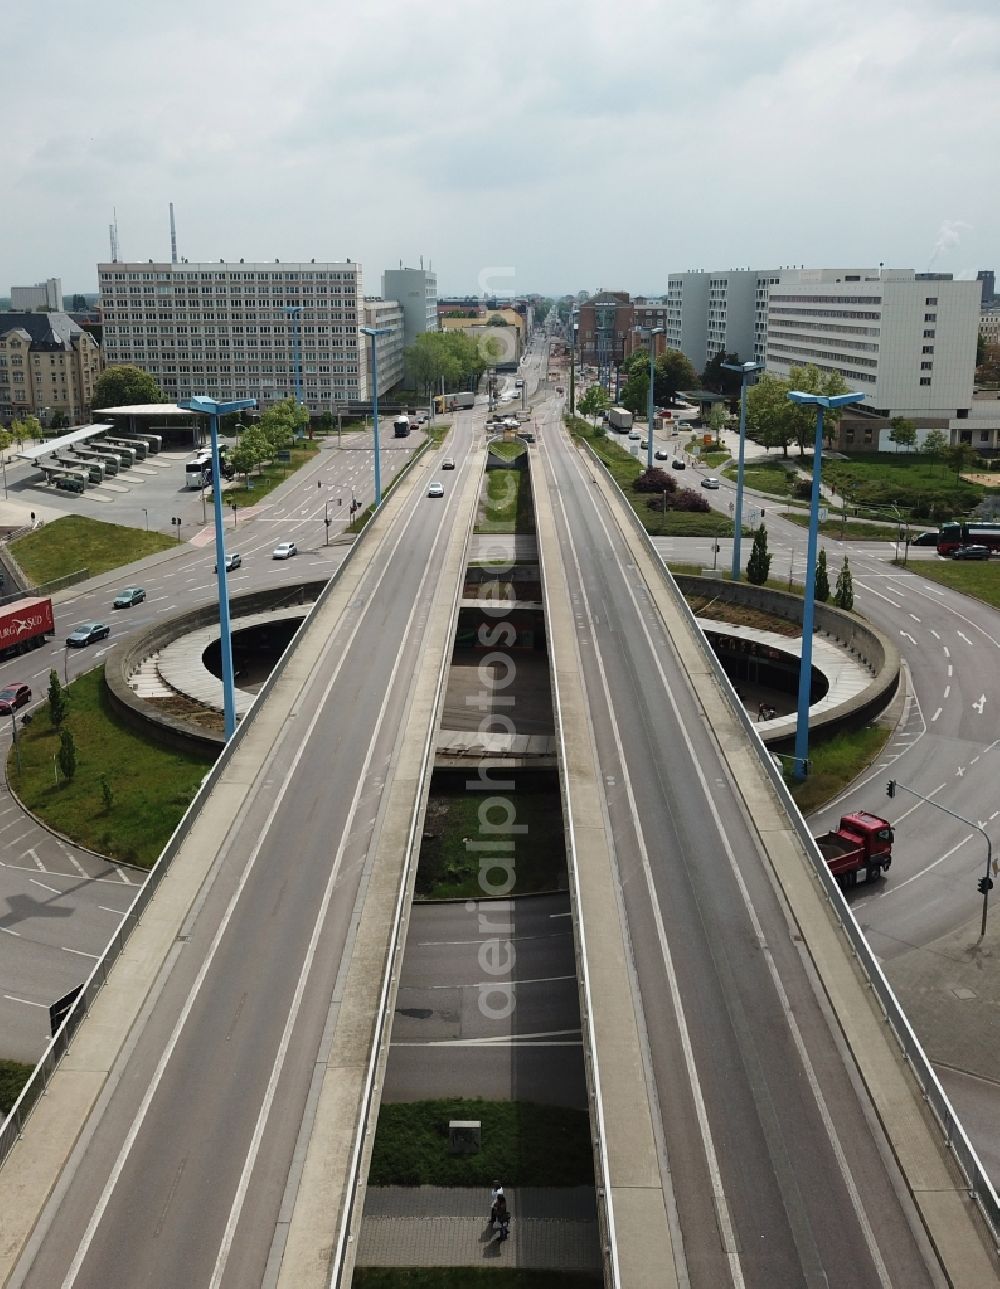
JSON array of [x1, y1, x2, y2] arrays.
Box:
[[557, 438, 893, 1289]]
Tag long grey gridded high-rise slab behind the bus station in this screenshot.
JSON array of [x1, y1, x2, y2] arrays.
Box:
[[98, 260, 367, 414]]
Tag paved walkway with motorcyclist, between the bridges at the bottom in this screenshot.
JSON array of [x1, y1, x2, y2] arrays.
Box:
[[357, 1186, 601, 1272]]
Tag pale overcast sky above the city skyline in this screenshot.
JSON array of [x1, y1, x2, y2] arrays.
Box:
[[0, 0, 1000, 294]]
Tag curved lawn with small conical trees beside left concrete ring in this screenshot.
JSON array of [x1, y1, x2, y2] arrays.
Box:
[[6, 666, 211, 867]]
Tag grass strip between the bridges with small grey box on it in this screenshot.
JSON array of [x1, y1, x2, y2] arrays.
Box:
[[369, 1097, 594, 1192]]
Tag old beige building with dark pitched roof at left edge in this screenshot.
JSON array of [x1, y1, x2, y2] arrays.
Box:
[[0, 313, 103, 424]]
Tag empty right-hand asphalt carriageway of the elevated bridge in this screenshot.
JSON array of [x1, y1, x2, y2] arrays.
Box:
[[536, 394, 996, 1289]]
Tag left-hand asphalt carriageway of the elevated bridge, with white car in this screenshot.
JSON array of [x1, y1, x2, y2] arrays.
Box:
[[4, 417, 472, 1289]]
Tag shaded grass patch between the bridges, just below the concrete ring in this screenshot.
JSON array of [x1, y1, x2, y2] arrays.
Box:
[[416, 791, 567, 900]]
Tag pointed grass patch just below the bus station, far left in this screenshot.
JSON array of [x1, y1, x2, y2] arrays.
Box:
[[10, 514, 177, 586]]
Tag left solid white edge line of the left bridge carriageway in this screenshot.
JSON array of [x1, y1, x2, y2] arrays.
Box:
[[54, 458, 443, 1289]]
